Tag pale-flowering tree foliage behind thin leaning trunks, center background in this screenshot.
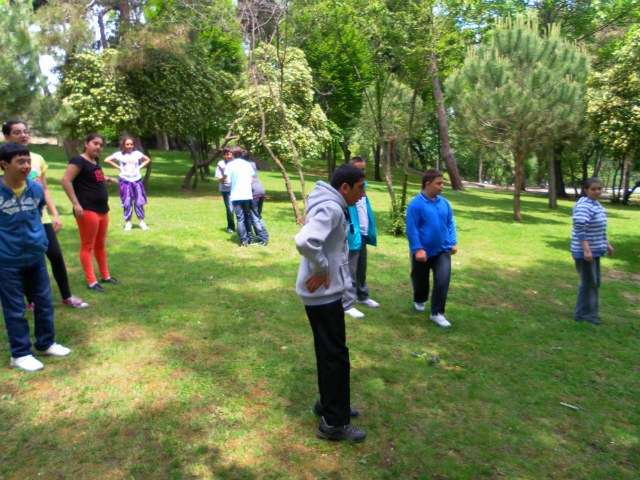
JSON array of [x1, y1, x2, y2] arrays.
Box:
[[234, 46, 331, 162]]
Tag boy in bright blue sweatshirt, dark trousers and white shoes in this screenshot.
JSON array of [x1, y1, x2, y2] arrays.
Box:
[[407, 168, 458, 328]]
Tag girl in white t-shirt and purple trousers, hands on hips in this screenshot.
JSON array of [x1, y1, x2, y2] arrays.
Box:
[[104, 135, 151, 232]]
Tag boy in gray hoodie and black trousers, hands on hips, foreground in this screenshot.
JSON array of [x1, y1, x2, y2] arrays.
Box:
[[295, 165, 367, 442]]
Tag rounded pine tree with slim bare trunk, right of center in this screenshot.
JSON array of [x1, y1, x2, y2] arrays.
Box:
[[447, 17, 589, 221]]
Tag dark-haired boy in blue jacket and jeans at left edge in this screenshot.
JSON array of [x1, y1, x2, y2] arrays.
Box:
[[0, 143, 71, 372]]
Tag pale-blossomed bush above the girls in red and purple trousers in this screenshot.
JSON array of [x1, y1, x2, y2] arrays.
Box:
[[56, 50, 138, 138]]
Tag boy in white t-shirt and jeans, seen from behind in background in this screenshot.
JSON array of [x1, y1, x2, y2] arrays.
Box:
[[224, 147, 255, 247]]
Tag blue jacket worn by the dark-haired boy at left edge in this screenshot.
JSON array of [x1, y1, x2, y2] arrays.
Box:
[[0, 176, 49, 267]]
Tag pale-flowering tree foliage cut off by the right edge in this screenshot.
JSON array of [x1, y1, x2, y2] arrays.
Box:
[[587, 29, 640, 158]]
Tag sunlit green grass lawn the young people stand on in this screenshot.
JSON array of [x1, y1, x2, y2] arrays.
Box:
[[0, 147, 640, 480]]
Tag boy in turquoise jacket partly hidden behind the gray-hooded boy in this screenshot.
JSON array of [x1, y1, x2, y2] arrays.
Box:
[[342, 157, 380, 318]]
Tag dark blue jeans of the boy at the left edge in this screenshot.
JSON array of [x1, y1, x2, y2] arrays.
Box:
[[0, 255, 54, 358]]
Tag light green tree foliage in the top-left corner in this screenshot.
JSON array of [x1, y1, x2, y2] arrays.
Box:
[[0, 0, 43, 119]]
